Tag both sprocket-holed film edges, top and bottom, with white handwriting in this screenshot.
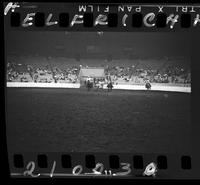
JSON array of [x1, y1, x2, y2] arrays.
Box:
[[4, 3, 200, 178]]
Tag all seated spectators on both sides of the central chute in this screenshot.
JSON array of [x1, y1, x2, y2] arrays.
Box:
[[7, 58, 191, 85]]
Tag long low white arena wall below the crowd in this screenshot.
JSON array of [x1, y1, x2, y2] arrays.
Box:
[[7, 82, 191, 93]]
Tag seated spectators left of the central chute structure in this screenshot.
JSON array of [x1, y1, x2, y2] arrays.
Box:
[[7, 62, 79, 83]]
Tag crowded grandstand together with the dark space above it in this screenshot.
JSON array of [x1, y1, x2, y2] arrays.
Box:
[[6, 32, 191, 89]]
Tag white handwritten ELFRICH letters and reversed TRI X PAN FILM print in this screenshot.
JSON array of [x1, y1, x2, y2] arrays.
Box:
[[4, 3, 200, 29]]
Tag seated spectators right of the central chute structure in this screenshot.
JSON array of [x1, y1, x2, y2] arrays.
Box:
[[106, 65, 191, 84]]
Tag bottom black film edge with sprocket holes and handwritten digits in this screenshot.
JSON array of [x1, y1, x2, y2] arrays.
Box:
[[9, 153, 193, 179]]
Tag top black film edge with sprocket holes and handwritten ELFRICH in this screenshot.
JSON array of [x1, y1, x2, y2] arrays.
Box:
[[4, 3, 200, 31]]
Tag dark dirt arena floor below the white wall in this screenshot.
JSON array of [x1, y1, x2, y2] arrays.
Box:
[[6, 88, 191, 153]]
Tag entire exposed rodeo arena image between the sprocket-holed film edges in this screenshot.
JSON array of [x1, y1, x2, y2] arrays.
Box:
[[6, 32, 191, 154]]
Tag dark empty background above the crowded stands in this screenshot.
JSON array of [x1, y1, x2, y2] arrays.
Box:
[[5, 31, 191, 58]]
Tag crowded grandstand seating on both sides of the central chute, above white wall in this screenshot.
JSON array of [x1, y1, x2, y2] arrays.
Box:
[[7, 56, 191, 86]]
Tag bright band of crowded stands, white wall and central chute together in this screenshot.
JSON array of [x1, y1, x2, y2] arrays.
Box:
[[7, 56, 191, 92]]
